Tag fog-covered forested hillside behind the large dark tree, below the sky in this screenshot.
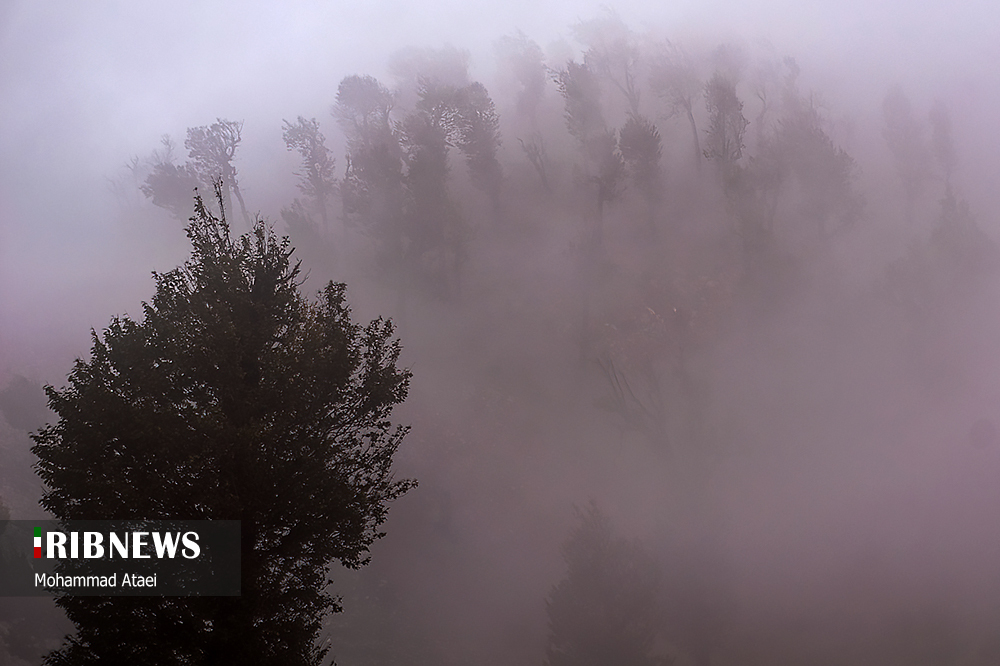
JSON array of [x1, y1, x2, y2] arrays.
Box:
[[0, 9, 1000, 666]]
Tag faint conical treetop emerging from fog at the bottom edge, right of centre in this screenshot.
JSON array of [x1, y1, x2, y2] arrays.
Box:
[[545, 504, 667, 666]]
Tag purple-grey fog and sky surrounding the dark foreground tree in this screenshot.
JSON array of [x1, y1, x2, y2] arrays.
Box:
[[0, 0, 1000, 666]]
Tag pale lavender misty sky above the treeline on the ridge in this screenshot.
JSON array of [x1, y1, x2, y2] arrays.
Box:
[[0, 0, 1000, 375]]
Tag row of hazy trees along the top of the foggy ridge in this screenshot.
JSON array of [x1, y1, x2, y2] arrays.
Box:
[[133, 13, 992, 322]]
